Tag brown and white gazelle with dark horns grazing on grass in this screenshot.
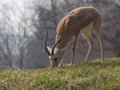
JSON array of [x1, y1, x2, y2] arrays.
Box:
[[44, 6, 104, 67]]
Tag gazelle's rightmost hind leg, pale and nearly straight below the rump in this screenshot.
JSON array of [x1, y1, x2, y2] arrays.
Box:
[[93, 30, 104, 61]]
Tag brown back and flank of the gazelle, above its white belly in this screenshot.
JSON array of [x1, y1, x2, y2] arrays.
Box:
[[56, 6, 101, 45]]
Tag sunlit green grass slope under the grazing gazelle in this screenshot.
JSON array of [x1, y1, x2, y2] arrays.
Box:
[[0, 58, 120, 90]]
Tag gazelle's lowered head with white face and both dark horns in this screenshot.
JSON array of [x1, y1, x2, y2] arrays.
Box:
[[44, 33, 64, 67]]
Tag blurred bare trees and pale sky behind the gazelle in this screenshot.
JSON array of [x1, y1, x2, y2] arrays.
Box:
[[0, 0, 120, 69]]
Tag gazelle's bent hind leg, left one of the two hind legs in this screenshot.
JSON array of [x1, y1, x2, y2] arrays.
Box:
[[82, 33, 94, 62]]
